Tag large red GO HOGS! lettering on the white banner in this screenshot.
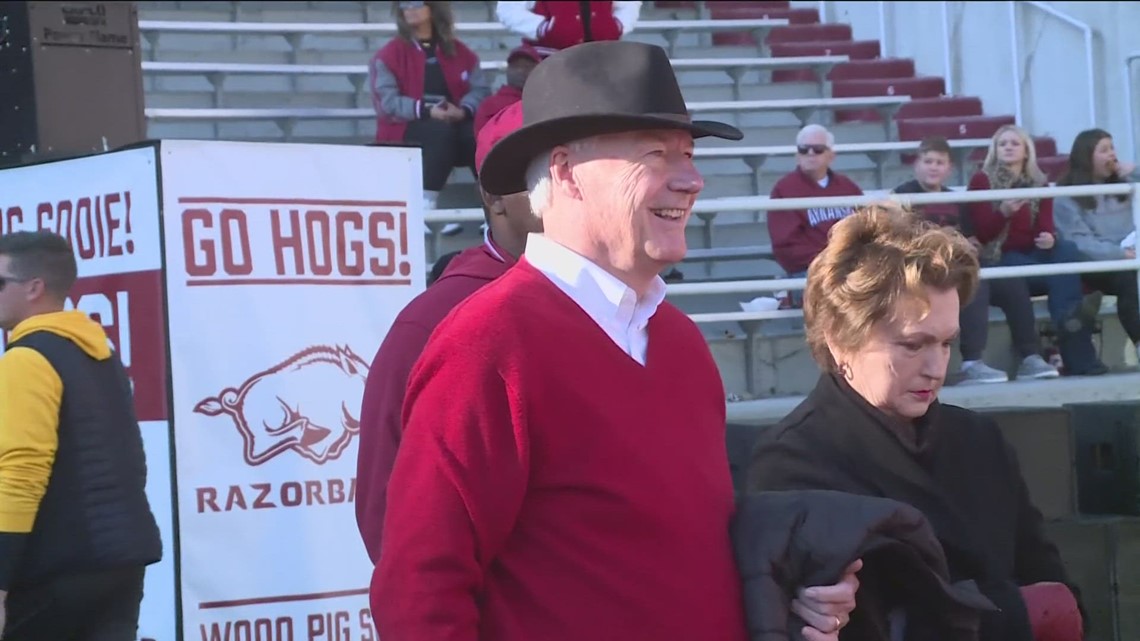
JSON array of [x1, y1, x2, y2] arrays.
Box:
[[179, 197, 412, 285]]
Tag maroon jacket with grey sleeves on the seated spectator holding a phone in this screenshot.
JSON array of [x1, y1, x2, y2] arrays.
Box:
[[369, 35, 479, 143]]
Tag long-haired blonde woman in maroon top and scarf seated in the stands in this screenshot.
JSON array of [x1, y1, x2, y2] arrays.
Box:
[[968, 124, 1108, 375]]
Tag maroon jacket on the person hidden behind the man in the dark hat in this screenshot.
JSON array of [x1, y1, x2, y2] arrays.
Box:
[[356, 238, 514, 563]]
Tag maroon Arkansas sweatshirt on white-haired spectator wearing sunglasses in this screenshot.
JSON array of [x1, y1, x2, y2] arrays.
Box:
[[768, 169, 863, 274]]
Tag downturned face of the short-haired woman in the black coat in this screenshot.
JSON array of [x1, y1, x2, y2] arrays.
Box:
[[831, 287, 959, 421]]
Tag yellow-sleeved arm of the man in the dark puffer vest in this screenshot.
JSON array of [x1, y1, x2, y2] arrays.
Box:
[[0, 347, 63, 592]]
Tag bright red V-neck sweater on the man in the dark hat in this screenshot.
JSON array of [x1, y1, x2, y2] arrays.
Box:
[[371, 260, 746, 641]]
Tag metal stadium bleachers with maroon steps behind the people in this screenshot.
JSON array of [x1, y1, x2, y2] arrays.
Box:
[[139, 1, 1140, 406]]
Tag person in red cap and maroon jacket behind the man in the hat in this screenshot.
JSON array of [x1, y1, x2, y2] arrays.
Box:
[[356, 98, 543, 563]]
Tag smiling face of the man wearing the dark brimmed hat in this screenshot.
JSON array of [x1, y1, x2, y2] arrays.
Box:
[[546, 129, 705, 289]]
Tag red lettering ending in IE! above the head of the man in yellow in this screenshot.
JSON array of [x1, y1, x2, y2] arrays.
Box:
[[0, 192, 135, 254]]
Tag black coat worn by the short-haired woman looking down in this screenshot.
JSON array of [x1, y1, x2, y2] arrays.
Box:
[[748, 374, 1076, 641]]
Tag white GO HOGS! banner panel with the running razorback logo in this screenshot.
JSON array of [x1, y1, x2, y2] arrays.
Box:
[[161, 141, 424, 641]]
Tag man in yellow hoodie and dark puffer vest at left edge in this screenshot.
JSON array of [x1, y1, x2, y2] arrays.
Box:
[[0, 226, 162, 641]]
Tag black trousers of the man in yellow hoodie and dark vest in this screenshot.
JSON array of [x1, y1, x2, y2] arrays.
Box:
[[3, 567, 146, 641]]
